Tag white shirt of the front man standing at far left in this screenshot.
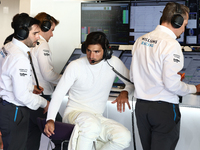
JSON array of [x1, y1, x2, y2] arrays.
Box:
[[0, 38, 47, 110]]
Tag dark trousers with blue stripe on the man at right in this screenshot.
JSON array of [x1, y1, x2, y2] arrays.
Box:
[[135, 99, 181, 150]]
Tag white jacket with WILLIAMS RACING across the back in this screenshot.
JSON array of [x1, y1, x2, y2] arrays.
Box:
[[130, 25, 196, 104]]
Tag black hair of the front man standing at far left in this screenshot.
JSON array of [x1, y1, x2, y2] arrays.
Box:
[[11, 13, 40, 39]]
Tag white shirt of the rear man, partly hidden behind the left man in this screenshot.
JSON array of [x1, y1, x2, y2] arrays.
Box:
[[31, 36, 61, 95]]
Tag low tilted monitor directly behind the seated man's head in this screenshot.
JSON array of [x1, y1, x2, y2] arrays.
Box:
[[60, 48, 123, 74]]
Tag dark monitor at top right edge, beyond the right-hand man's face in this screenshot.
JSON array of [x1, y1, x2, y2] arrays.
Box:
[[185, 0, 200, 45]]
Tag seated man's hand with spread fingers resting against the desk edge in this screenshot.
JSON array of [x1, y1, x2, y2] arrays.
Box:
[[112, 91, 131, 113]]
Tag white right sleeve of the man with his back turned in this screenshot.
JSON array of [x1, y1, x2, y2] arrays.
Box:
[[162, 44, 196, 96]]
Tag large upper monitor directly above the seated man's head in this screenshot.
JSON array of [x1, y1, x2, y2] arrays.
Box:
[[81, 1, 129, 45]]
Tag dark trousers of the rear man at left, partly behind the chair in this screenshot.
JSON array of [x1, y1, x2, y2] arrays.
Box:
[[27, 95, 62, 150]]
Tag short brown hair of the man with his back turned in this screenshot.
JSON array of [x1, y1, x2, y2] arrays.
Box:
[[160, 2, 190, 24]]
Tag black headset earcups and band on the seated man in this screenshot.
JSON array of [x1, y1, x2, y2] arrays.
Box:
[[81, 32, 113, 60]]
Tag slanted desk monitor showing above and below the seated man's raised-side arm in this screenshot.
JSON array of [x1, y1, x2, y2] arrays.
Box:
[[113, 50, 132, 88]]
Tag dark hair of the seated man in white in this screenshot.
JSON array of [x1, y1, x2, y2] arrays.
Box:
[[84, 31, 109, 50]]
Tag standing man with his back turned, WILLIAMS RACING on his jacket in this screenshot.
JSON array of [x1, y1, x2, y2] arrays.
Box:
[[130, 2, 200, 150]]
